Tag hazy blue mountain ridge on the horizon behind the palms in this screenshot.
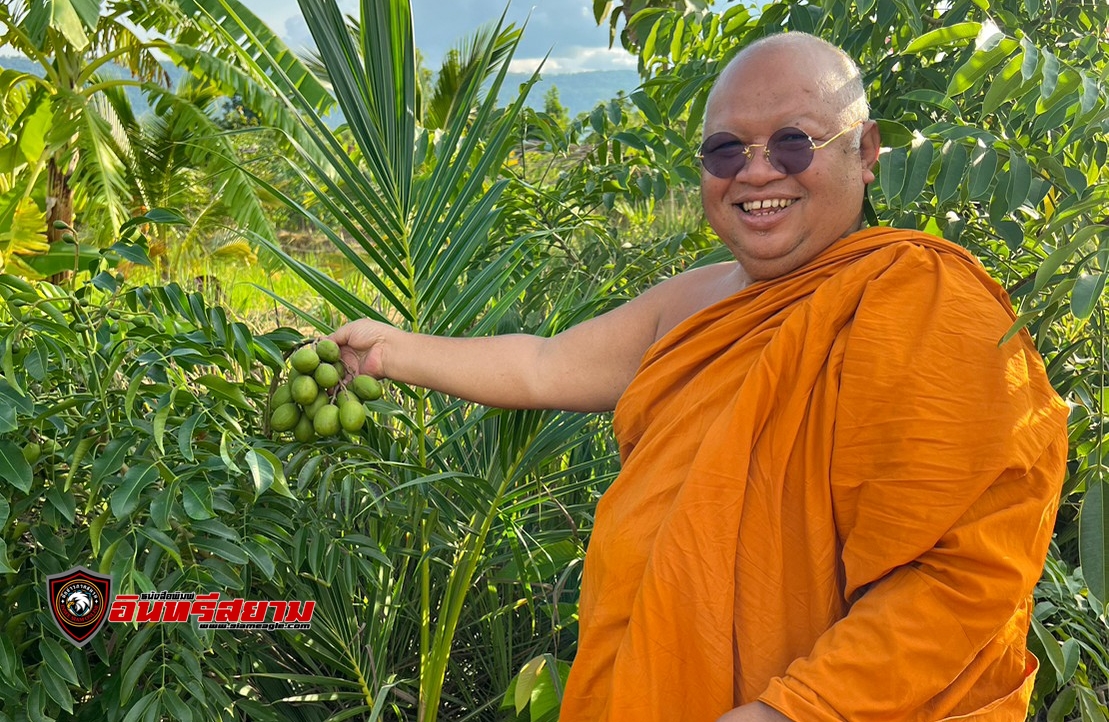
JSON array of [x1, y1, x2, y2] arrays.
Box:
[[0, 55, 640, 123]]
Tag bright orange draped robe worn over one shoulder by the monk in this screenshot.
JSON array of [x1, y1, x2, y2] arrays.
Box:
[[561, 228, 1067, 722]]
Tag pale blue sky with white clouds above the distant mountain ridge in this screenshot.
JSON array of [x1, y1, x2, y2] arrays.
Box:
[[242, 0, 635, 74]]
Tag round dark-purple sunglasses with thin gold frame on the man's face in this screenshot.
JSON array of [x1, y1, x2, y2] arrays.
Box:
[[696, 120, 864, 179]]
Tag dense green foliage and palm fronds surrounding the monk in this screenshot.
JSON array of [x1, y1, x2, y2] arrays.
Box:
[[0, 0, 1109, 722]]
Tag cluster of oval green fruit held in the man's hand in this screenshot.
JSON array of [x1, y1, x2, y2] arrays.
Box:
[[269, 338, 381, 441]]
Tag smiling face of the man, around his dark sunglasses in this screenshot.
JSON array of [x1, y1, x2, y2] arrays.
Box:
[[701, 48, 879, 281]]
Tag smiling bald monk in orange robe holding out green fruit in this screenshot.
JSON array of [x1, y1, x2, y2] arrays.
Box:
[[333, 33, 1067, 722]]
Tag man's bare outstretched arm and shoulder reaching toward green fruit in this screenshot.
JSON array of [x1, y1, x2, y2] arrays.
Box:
[[330, 266, 749, 411]]
